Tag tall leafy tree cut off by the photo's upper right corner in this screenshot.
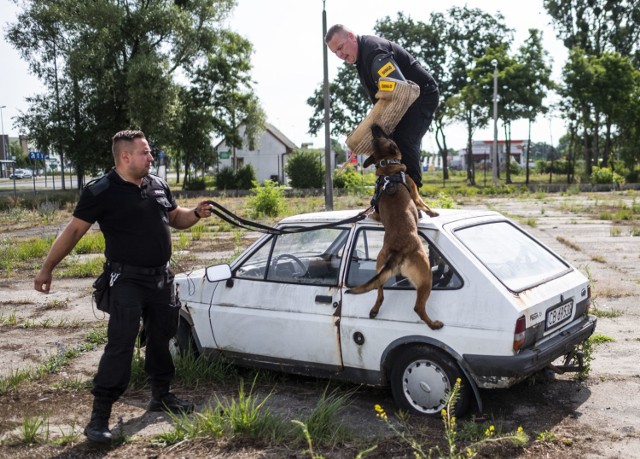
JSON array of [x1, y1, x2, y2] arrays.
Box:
[[544, 0, 640, 175]]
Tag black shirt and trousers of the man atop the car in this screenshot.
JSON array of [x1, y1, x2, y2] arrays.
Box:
[[356, 35, 439, 188]]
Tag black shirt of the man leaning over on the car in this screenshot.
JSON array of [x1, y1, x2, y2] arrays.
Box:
[[356, 35, 438, 104]]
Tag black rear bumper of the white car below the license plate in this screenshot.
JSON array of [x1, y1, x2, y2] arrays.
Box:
[[463, 317, 597, 388]]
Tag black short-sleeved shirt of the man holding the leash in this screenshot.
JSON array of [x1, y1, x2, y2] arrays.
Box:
[[73, 169, 178, 267]]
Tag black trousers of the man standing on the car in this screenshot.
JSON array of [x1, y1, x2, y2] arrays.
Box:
[[391, 87, 440, 188]]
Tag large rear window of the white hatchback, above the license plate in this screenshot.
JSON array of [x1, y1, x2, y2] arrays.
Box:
[[455, 222, 570, 292]]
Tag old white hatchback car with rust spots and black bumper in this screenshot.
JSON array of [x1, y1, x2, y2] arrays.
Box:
[[175, 210, 596, 415]]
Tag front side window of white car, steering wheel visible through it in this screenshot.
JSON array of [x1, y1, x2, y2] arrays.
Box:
[[235, 228, 348, 285]]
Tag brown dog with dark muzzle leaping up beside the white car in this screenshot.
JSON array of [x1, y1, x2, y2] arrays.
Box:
[[346, 124, 443, 330]]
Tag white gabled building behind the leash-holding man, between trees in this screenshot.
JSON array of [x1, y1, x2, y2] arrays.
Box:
[[214, 123, 297, 183]]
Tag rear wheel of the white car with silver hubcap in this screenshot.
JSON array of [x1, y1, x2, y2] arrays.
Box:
[[390, 345, 471, 417]]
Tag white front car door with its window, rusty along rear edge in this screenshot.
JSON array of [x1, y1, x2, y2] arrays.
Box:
[[210, 228, 349, 371]]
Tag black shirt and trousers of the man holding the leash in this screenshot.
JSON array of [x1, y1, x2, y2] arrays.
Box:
[[73, 170, 178, 402]]
